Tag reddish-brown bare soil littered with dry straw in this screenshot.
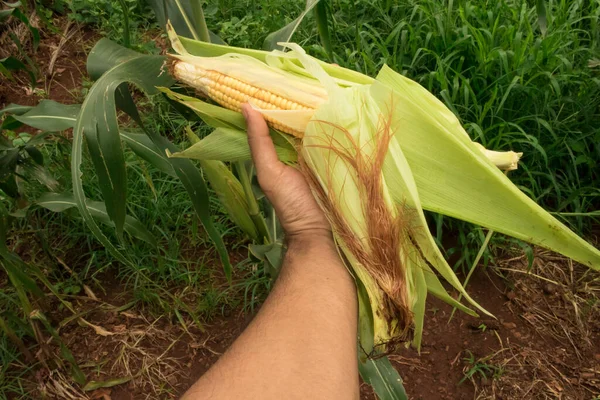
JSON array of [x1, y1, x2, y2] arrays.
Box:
[[0, 18, 600, 400]]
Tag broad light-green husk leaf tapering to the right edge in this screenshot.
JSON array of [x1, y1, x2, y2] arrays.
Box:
[[377, 67, 600, 269]]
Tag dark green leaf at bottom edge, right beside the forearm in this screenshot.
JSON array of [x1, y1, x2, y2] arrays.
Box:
[[358, 357, 408, 400]]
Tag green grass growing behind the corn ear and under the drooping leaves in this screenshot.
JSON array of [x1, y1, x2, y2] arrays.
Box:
[[0, 0, 600, 396]]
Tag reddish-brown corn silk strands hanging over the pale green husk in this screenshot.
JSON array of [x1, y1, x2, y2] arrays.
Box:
[[299, 110, 417, 348]]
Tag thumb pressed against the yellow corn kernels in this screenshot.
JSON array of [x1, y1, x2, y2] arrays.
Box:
[[242, 104, 282, 179]]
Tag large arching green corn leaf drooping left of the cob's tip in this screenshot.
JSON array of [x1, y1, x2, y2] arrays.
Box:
[[71, 39, 172, 263]]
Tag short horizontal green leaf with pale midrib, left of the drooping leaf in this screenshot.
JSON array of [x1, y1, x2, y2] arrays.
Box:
[[9, 100, 81, 131]]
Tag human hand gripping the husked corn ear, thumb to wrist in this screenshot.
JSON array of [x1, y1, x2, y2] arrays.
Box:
[[242, 104, 331, 241]]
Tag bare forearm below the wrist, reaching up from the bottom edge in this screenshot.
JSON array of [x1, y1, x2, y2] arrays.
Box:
[[184, 238, 358, 400]]
